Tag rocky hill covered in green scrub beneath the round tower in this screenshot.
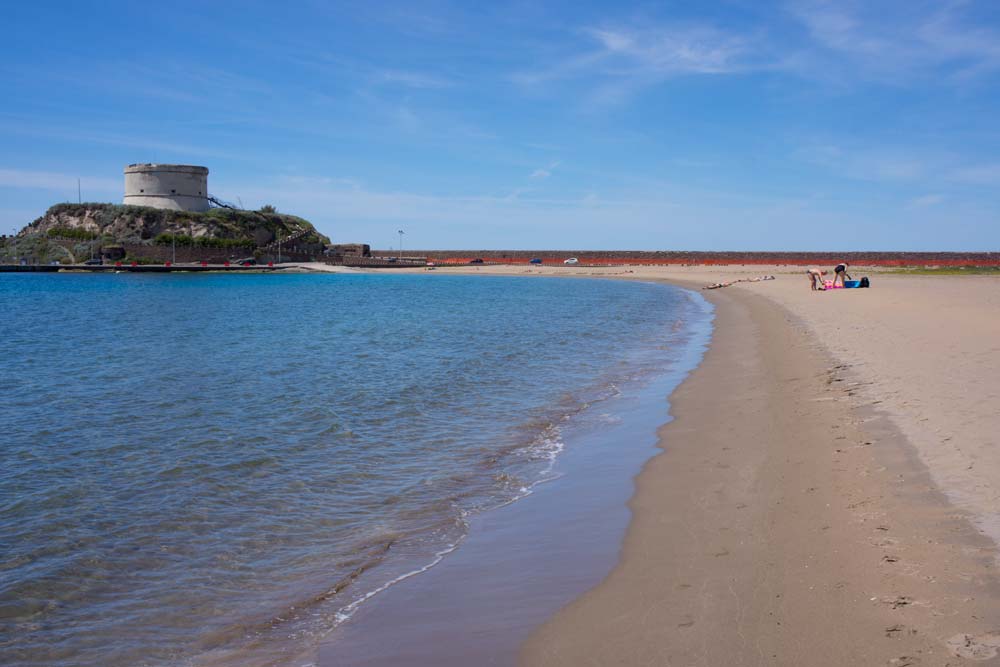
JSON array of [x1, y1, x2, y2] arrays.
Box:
[[18, 204, 330, 247]]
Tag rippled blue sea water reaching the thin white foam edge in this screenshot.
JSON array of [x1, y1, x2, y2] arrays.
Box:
[[0, 274, 706, 666]]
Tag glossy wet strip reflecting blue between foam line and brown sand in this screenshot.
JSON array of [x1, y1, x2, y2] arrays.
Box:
[[318, 285, 713, 667]]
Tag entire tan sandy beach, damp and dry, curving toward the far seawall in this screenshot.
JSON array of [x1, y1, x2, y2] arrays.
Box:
[[406, 267, 1000, 666]]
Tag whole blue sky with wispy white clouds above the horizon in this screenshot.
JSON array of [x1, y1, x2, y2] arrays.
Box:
[[0, 0, 1000, 250]]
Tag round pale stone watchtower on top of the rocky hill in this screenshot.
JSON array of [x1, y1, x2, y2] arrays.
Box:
[[122, 164, 209, 211]]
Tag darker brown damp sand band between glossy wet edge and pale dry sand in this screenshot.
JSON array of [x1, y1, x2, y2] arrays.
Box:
[[520, 274, 1000, 665]]
